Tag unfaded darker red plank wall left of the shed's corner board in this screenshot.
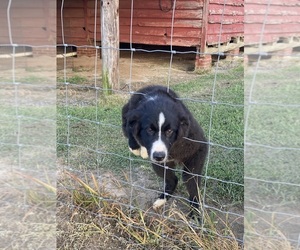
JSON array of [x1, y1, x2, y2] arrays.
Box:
[[57, 0, 203, 46]]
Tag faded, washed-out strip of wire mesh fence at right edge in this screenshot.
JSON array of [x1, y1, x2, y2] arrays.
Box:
[[244, 1, 299, 249]]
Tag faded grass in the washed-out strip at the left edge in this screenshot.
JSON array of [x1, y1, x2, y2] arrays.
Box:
[[0, 89, 56, 249]]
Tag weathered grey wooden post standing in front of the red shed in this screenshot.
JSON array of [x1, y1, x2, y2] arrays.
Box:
[[101, 0, 119, 94]]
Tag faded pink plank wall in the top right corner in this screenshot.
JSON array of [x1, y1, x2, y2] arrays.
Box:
[[245, 0, 300, 44]]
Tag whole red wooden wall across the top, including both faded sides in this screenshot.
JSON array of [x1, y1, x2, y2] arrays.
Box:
[[0, 0, 300, 51]]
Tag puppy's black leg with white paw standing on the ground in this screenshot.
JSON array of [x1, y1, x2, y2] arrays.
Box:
[[152, 162, 178, 210]]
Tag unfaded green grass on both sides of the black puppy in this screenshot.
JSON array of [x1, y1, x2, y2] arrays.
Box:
[[57, 67, 244, 205]]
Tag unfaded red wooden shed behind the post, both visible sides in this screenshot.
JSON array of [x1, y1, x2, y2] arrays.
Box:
[[57, 0, 244, 67]]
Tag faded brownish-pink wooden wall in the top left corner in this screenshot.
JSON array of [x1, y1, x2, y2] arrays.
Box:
[[0, 0, 56, 46]]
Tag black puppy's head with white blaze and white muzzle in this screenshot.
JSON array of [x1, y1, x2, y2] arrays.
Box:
[[128, 107, 189, 164]]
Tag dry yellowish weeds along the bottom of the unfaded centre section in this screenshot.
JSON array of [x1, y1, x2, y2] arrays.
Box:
[[58, 171, 241, 249]]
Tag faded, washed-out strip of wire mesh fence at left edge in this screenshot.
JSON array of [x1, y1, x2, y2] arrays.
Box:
[[0, 1, 56, 249]]
